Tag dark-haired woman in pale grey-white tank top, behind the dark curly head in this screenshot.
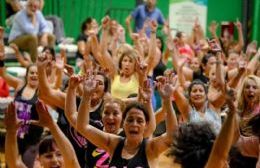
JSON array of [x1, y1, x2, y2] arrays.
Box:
[[174, 80, 222, 132]]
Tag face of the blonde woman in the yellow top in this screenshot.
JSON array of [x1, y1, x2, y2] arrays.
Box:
[[121, 56, 135, 76]]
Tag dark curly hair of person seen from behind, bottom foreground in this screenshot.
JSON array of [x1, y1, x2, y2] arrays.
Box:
[[169, 122, 216, 168]]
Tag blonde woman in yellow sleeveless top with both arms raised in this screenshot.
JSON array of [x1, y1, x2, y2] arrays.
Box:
[[92, 17, 159, 98]]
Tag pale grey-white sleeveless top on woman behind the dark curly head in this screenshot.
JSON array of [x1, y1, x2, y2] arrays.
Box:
[[189, 103, 221, 134]]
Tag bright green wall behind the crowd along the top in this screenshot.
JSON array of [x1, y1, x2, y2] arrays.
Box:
[[0, 0, 260, 41]]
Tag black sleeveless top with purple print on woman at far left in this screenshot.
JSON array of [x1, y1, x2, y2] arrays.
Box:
[[14, 86, 43, 154]]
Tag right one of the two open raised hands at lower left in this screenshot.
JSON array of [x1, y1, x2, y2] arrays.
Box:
[[30, 100, 54, 128]]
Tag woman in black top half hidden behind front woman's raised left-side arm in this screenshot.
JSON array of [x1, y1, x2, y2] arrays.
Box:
[[37, 52, 109, 167]]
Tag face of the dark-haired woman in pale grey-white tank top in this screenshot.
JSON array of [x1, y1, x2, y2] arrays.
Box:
[[190, 84, 207, 104]]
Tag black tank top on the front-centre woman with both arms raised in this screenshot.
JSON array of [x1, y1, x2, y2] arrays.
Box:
[[109, 138, 149, 168]]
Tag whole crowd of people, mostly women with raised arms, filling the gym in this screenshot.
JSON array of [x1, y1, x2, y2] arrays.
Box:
[[0, 0, 260, 168]]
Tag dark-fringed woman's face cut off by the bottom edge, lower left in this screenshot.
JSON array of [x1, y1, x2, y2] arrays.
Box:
[[39, 144, 64, 168]]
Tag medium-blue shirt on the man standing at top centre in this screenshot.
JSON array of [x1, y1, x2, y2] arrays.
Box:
[[131, 5, 164, 36]]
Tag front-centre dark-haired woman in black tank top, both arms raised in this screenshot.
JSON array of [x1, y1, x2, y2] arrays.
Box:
[[77, 73, 177, 167]]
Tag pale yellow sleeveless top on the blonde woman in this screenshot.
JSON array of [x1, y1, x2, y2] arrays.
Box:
[[111, 75, 139, 99]]
